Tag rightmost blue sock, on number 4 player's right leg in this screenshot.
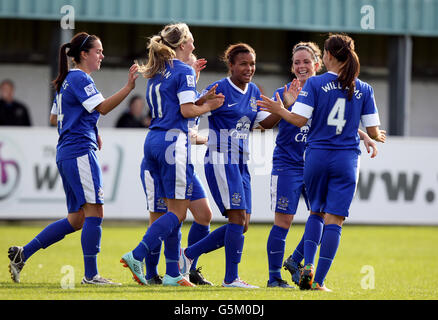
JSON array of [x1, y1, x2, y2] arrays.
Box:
[[314, 224, 342, 286]]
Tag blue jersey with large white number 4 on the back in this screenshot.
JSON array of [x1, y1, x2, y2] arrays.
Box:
[[292, 72, 380, 150]]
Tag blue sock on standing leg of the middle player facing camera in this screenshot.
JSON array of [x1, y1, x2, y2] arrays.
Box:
[[224, 223, 245, 283]]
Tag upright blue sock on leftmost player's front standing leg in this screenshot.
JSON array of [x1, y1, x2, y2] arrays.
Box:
[[81, 217, 103, 279]]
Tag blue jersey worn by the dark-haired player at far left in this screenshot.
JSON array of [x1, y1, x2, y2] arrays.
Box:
[[52, 69, 105, 161]]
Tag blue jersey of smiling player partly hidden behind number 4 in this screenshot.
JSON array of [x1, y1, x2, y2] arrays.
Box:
[[272, 83, 309, 173]]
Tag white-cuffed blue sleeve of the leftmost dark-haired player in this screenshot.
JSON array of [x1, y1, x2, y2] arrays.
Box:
[[71, 73, 105, 113]]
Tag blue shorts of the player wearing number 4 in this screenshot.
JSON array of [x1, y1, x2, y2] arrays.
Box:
[[304, 148, 360, 217]]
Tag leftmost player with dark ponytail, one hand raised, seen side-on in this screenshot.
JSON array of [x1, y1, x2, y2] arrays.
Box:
[[9, 32, 138, 285]]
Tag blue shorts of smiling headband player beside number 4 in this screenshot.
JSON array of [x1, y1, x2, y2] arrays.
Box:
[[271, 170, 310, 215]]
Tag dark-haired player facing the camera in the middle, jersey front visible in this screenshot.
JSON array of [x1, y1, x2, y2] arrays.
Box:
[[180, 43, 279, 288]]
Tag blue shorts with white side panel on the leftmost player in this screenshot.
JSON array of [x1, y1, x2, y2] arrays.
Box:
[[57, 151, 104, 213]]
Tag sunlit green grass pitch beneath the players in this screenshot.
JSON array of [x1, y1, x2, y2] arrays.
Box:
[[0, 221, 438, 300]]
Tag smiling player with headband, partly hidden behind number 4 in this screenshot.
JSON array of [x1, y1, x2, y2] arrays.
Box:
[[267, 42, 377, 288]]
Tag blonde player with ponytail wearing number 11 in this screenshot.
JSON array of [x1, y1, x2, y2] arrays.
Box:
[[121, 23, 224, 286]]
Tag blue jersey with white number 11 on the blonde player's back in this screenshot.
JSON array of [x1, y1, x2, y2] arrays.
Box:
[[146, 59, 197, 133]]
